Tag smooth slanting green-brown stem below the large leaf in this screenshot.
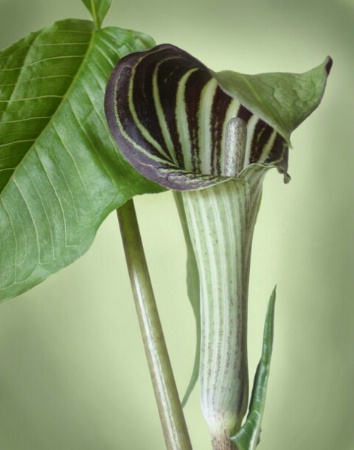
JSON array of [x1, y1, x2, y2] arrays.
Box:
[[117, 200, 192, 450]]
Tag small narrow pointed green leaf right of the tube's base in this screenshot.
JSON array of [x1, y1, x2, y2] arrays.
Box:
[[231, 288, 276, 450]]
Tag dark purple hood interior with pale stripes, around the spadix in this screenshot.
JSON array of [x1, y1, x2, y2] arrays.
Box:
[[105, 44, 288, 190]]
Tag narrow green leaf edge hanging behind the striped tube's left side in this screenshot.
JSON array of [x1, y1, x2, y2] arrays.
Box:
[[174, 192, 201, 407]]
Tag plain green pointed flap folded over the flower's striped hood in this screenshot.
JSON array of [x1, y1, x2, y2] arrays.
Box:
[[214, 57, 332, 146]]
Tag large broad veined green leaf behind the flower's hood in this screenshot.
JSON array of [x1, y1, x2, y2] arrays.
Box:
[[0, 20, 161, 300]]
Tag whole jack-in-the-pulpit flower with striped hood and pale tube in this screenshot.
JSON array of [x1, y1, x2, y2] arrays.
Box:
[[105, 45, 332, 450]]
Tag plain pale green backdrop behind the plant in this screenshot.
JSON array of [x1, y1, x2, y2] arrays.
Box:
[[0, 0, 354, 450]]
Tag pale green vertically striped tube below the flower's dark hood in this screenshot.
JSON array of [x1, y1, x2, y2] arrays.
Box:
[[182, 180, 261, 450]]
